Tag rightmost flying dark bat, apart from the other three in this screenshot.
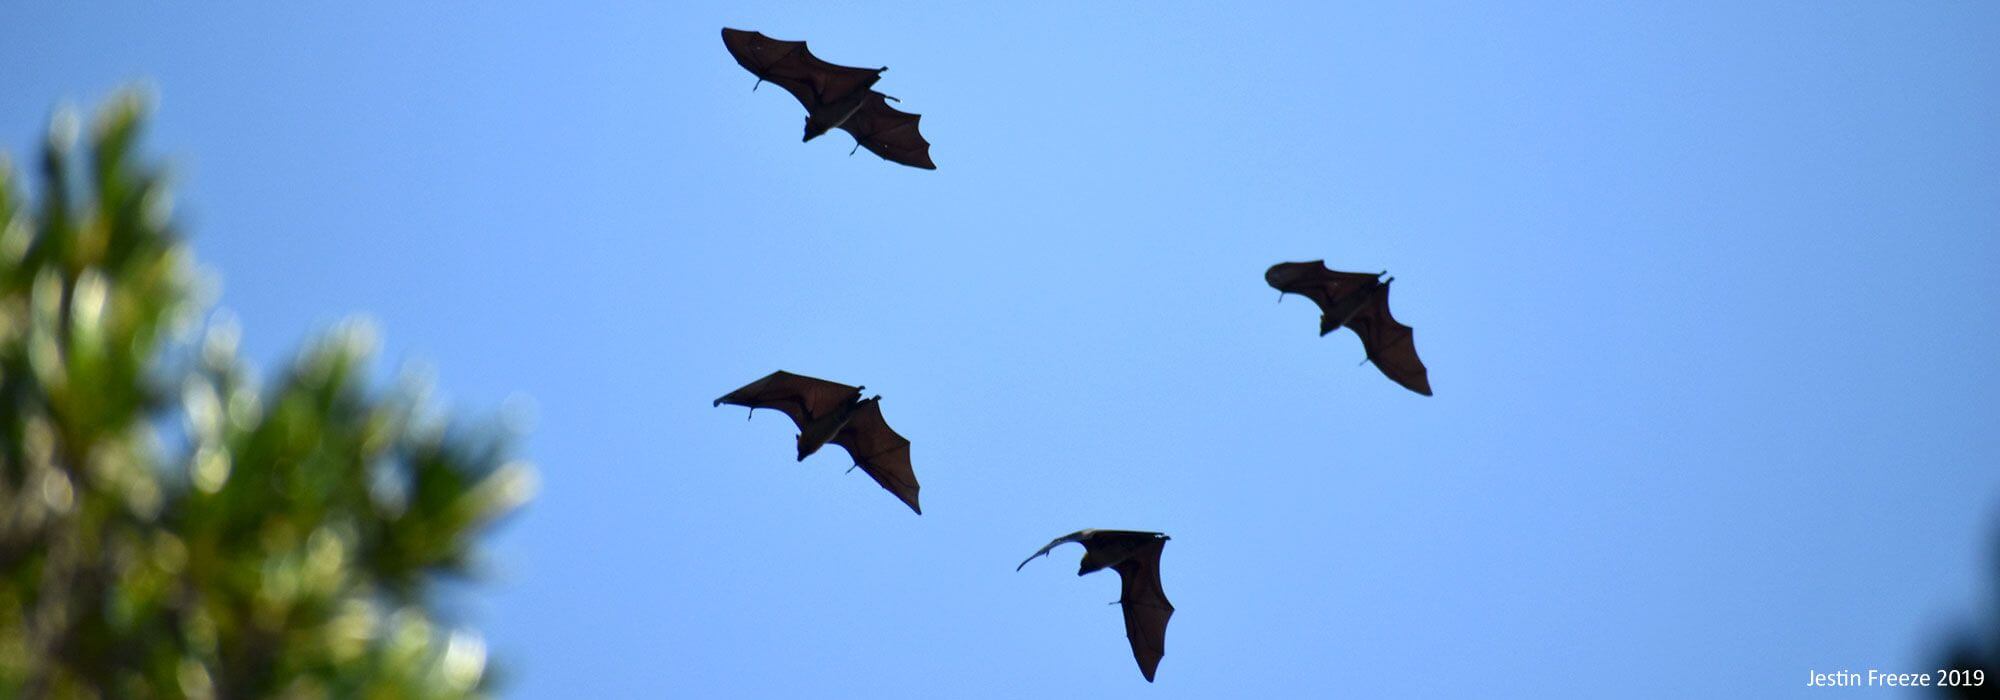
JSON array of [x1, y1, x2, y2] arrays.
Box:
[[1264, 260, 1430, 396]]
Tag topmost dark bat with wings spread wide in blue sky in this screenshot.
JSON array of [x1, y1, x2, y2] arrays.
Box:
[[722, 28, 938, 170]]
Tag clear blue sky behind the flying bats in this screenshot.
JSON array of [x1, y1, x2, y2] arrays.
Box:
[[0, 2, 2000, 698]]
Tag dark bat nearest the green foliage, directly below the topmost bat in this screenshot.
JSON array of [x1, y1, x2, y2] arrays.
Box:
[[716, 370, 924, 514]]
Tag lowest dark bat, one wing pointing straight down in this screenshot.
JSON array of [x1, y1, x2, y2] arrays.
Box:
[[1014, 530, 1174, 682]]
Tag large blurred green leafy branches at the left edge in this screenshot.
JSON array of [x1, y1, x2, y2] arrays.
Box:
[[0, 96, 532, 698]]
